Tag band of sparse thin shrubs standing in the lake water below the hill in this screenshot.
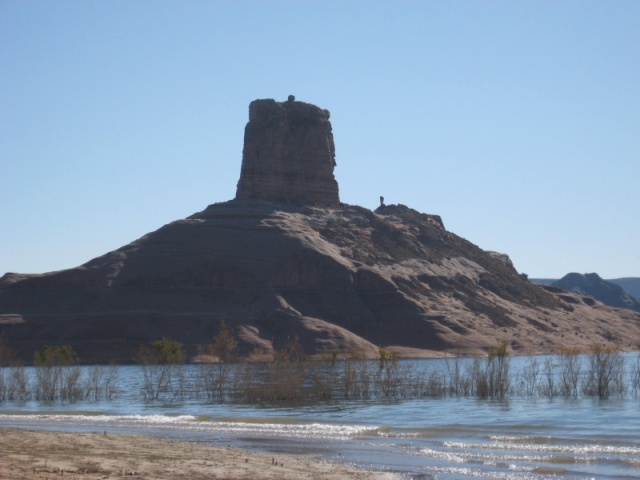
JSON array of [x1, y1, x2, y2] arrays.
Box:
[[0, 334, 640, 404]]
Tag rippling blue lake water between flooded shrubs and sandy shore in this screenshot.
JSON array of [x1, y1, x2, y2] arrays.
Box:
[[0, 354, 640, 479]]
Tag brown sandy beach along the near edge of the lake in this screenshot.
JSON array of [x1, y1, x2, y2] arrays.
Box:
[[0, 428, 399, 480]]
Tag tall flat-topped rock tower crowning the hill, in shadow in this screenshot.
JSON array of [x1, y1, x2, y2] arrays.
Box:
[[236, 97, 340, 206]]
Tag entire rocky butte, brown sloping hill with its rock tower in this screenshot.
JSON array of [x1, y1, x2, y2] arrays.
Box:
[[0, 100, 640, 363]]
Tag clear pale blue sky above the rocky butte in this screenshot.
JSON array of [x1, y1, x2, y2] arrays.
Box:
[[0, 0, 640, 278]]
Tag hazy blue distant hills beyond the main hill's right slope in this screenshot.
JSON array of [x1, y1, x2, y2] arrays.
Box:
[[532, 273, 640, 312]]
